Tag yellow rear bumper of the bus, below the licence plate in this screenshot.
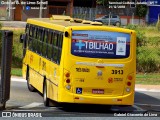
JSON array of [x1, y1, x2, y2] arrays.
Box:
[[59, 92, 134, 105]]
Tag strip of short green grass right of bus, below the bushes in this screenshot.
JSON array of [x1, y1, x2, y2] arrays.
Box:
[[136, 73, 160, 85]]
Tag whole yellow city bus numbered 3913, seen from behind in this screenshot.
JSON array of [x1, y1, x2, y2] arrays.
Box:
[[21, 16, 136, 106]]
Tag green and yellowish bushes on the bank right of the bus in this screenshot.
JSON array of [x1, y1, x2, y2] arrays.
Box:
[[126, 25, 160, 72]]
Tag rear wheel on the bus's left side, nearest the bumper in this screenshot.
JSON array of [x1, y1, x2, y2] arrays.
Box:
[[43, 82, 49, 107]]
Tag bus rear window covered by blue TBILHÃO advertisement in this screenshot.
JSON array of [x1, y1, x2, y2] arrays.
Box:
[[71, 30, 130, 59]]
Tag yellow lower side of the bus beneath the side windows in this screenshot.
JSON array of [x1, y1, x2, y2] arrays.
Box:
[[23, 50, 60, 101]]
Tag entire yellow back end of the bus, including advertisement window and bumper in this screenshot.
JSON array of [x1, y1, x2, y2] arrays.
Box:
[[59, 27, 136, 105]]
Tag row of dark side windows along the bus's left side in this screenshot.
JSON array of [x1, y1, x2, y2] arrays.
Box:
[[25, 23, 63, 65]]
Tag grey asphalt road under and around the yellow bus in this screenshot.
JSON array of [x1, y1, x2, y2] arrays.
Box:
[[4, 79, 160, 120]]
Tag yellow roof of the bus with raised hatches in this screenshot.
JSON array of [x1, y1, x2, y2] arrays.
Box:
[[27, 16, 132, 32]]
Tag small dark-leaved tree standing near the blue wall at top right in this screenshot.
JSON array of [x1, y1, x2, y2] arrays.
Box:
[[136, 4, 148, 24]]
